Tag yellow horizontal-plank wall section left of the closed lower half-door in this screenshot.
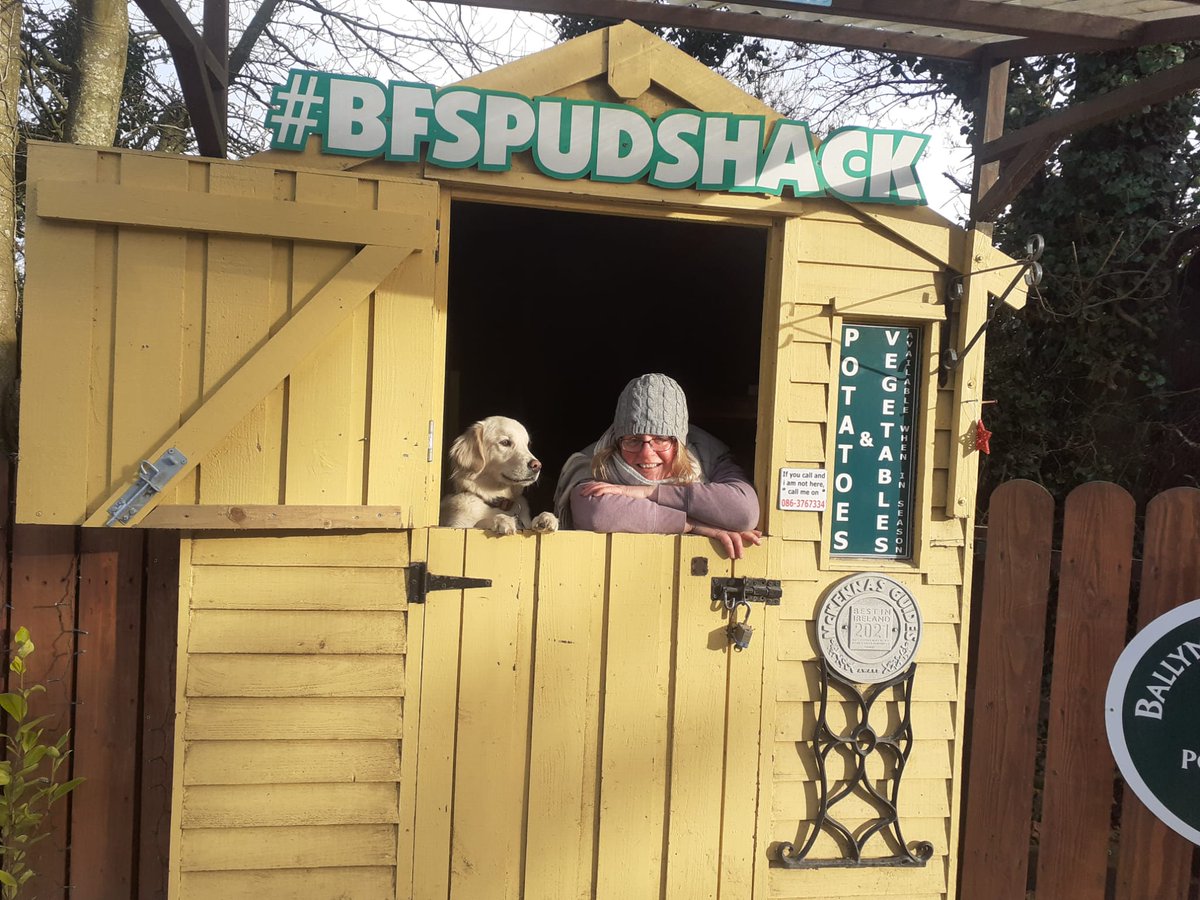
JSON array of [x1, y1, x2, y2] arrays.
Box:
[[173, 532, 409, 900]]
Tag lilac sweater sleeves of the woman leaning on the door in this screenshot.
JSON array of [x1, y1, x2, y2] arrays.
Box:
[[571, 457, 758, 534]]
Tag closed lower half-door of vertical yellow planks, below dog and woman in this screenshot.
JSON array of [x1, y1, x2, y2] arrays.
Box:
[[397, 529, 778, 900]]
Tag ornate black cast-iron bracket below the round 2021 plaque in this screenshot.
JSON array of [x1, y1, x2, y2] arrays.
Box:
[[776, 658, 934, 869]]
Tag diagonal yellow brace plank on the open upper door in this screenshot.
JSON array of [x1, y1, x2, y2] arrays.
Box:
[[84, 246, 415, 526]]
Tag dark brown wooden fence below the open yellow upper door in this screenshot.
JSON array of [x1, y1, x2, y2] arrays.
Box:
[[0, 468, 179, 900]]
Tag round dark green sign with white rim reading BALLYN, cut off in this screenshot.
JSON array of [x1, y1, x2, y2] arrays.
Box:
[[1105, 600, 1200, 845]]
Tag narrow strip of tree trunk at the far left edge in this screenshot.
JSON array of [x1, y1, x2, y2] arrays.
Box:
[[0, 0, 25, 456]]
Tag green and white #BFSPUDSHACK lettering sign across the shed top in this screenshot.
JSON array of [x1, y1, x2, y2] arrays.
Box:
[[266, 70, 929, 205]]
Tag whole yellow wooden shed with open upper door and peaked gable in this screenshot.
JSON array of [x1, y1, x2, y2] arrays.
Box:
[[17, 23, 1021, 900]]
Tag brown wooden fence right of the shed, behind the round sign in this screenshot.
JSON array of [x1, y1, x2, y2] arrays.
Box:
[[960, 481, 1200, 900]]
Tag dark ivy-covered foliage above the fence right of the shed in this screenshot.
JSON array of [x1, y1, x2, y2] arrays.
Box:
[[916, 46, 1200, 502]]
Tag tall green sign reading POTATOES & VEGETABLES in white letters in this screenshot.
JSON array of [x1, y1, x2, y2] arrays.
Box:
[[830, 324, 920, 559]]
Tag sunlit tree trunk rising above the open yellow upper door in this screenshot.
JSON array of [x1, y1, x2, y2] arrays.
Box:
[[67, 0, 130, 146]]
